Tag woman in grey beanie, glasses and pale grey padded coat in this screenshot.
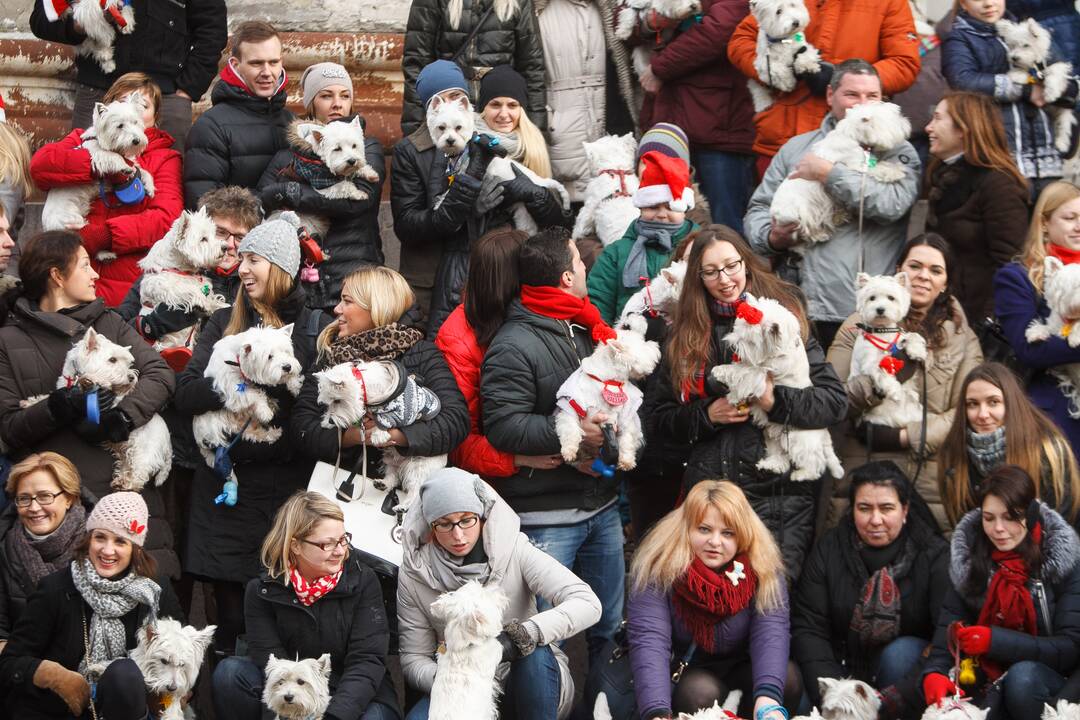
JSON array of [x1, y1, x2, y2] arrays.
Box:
[[397, 467, 600, 720]]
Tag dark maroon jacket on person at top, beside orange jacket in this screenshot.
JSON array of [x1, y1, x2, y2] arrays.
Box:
[[642, 0, 754, 153]]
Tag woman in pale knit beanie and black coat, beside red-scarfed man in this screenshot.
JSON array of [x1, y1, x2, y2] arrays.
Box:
[[258, 63, 387, 312]]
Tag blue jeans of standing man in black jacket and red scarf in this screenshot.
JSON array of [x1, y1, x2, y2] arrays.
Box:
[[522, 505, 626, 664]]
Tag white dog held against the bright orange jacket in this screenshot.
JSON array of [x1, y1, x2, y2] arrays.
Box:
[[746, 0, 821, 112]]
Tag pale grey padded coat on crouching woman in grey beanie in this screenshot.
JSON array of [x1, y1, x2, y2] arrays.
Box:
[[397, 479, 600, 720]]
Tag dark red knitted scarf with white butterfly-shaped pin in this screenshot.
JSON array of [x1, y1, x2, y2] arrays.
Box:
[[672, 554, 757, 653]]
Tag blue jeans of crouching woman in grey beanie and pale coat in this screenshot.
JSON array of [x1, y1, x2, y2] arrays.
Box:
[[403, 646, 562, 720]]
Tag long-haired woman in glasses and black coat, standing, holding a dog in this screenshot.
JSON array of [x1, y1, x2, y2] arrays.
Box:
[[650, 225, 848, 576]]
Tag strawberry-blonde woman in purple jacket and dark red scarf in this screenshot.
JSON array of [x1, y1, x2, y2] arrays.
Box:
[[626, 480, 802, 720]]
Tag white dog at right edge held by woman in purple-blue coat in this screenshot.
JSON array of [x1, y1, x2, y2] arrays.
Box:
[[1025, 256, 1080, 418]]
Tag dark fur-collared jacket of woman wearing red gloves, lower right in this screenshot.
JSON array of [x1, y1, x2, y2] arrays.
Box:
[[924, 501, 1080, 677]]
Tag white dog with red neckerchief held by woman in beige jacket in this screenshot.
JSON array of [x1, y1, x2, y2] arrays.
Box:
[[851, 272, 927, 427]]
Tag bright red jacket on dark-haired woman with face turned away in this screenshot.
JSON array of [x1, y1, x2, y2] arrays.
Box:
[[435, 305, 516, 477]]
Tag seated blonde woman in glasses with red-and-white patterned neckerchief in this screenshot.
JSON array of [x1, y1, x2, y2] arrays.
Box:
[[213, 492, 401, 720]]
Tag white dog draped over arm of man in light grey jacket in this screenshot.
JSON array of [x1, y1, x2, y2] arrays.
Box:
[[769, 103, 912, 249]]
